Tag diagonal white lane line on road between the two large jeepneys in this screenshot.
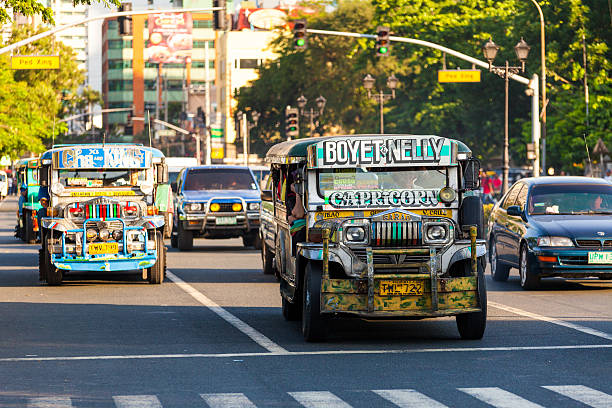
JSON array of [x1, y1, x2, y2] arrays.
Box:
[[166, 271, 288, 353]]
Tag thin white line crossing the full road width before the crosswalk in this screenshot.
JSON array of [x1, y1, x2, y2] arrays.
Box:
[[0, 344, 612, 363]]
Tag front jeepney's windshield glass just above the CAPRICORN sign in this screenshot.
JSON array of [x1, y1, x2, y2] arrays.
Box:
[[318, 167, 447, 197]]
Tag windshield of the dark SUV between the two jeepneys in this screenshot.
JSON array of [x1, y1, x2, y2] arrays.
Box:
[[183, 169, 257, 190]]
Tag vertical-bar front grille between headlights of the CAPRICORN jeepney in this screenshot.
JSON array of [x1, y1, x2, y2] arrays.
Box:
[[370, 221, 421, 247]]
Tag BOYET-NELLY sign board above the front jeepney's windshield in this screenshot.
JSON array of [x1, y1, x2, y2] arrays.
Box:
[[308, 135, 456, 168]]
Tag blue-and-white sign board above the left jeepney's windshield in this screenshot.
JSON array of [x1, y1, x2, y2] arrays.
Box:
[[53, 146, 151, 169]]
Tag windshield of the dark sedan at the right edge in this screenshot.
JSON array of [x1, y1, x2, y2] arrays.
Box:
[[528, 184, 612, 215]]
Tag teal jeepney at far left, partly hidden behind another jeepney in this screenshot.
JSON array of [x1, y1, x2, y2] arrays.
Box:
[[15, 158, 41, 244]]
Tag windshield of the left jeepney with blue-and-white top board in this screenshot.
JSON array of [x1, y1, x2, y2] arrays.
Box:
[[58, 169, 147, 188]]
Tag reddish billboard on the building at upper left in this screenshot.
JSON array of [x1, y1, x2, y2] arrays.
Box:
[[145, 13, 193, 63]]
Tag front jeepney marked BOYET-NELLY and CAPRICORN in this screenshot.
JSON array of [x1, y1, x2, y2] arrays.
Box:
[[262, 135, 487, 341]]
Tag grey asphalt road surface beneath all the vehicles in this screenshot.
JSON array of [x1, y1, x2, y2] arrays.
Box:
[[0, 195, 612, 408]]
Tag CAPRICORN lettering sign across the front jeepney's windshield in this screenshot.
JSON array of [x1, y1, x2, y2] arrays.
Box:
[[325, 190, 439, 210]]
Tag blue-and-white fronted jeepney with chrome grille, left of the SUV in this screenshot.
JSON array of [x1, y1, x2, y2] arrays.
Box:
[[39, 144, 170, 285]]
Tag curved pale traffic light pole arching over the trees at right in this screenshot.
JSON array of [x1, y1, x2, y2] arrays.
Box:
[[306, 28, 540, 177]]
